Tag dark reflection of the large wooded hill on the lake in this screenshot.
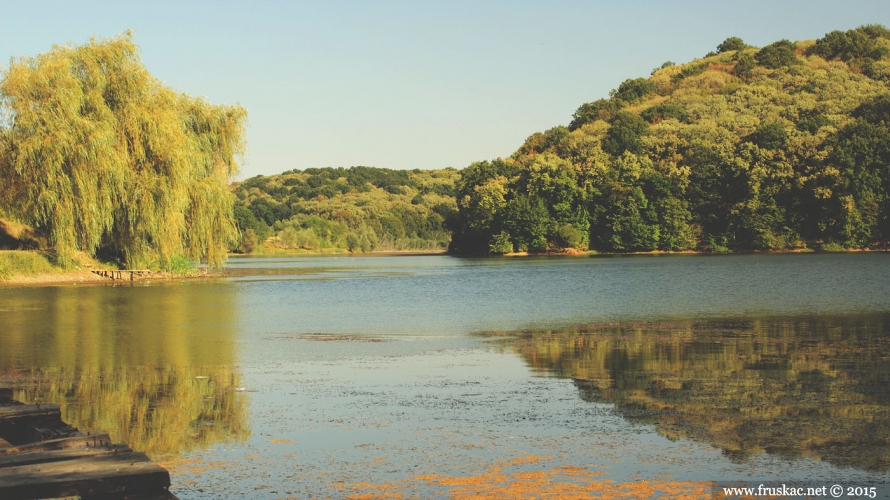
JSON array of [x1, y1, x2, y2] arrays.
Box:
[[492, 315, 890, 471]]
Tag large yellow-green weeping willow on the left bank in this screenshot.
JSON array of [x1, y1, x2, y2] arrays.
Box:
[[0, 32, 247, 267]]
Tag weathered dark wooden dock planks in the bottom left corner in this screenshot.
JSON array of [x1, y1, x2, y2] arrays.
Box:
[[0, 388, 176, 500]]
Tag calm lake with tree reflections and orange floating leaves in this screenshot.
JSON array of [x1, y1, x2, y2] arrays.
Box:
[[0, 253, 890, 499]]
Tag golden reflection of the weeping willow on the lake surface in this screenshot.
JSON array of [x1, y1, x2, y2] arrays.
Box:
[[0, 285, 250, 458]]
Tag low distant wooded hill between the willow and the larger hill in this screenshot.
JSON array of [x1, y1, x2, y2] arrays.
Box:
[[231, 167, 458, 252]]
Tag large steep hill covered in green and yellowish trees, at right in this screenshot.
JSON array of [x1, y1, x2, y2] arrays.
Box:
[[451, 25, 890, 253]]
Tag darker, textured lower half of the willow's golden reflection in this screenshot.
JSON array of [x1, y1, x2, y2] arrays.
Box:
[[16, 366, 250, 458]]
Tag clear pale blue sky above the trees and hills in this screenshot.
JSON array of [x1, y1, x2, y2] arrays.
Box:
[[0, 0, 890, 178]]
